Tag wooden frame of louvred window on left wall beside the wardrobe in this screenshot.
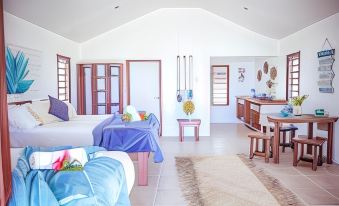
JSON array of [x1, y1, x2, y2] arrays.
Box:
[[57, 54, 71, 102]]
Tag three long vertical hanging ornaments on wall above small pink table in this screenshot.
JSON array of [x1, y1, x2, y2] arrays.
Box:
[[177, 55, 193, 102]]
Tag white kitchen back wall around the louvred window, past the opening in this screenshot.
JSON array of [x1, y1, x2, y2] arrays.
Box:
[[211, 57, 255, 123]]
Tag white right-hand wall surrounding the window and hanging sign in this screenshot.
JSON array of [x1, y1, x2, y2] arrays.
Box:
[[279, 13, 339, 162]]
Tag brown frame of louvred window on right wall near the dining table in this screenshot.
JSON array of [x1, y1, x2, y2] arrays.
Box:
[[286, 51, 300, 101]]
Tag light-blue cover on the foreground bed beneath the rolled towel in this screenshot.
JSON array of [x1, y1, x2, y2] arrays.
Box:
[[9, 146, 130, 206]]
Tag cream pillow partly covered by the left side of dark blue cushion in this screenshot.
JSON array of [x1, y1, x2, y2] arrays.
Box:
[[28, 100, 62, 124]]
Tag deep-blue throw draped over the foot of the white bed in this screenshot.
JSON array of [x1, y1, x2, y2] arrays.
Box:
[[93, 114, 164, 163]]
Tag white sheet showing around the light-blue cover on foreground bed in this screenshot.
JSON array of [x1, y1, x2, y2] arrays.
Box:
[[11, 148, 135, 193]]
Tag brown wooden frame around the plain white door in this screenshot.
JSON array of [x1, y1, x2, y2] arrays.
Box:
[[126, 60, 162, 136]]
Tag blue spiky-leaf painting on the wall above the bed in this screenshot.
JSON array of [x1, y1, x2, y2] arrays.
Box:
[[6, 47, 34, 94]]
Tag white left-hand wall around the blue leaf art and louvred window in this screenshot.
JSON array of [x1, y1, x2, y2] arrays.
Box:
[[4, 12, 80, 106]]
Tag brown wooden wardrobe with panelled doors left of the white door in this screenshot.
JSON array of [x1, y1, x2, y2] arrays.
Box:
[[78, 63, 123, 114]]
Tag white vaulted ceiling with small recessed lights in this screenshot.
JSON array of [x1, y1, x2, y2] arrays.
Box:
[[4, 0, 339, 42]]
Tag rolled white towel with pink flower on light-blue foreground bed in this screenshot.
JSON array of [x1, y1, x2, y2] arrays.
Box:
[[29, 148, 88, 170]]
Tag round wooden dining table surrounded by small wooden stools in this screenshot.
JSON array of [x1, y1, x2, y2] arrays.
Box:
[[267, 113, 338, 164]]
